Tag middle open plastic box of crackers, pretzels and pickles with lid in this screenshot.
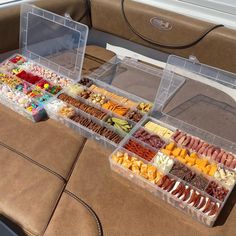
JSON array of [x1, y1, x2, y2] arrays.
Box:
[[45, 55, 181, 148]]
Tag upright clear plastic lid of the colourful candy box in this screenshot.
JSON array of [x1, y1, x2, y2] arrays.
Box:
[[20, 4, 88, 80]]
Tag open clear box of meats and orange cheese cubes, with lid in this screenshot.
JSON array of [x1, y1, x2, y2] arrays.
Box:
[[109, 56, 236, 227]]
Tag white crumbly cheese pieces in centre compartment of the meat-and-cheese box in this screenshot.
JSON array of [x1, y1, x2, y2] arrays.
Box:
[[153, 152, 174, 173]]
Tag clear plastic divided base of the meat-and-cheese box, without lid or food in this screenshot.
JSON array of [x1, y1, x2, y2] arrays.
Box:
[[109, 103, 236, 227]]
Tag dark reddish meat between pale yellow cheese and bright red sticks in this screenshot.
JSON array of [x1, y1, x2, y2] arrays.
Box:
[[134, 128, 165, 149]]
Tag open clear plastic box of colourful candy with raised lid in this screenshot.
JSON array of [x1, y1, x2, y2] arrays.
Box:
[[0, 4, 88, 121]]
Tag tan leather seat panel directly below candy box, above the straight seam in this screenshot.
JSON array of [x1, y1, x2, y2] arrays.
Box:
[[0, 105, 85, 179]]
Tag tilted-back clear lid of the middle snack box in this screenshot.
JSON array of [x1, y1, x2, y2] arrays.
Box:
[[89, 58, 184, 110]]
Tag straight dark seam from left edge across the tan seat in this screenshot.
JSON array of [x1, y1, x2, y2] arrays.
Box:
[[0, 141, 66, 183]]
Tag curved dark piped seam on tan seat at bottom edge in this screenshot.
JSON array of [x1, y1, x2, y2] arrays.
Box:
[[64, 189, 103, 236]]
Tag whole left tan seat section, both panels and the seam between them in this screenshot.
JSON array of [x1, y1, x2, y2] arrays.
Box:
[[0, 106, 85, 235]]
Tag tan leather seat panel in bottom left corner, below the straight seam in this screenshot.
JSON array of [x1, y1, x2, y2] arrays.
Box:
[[0, 146, 65, 235]]
